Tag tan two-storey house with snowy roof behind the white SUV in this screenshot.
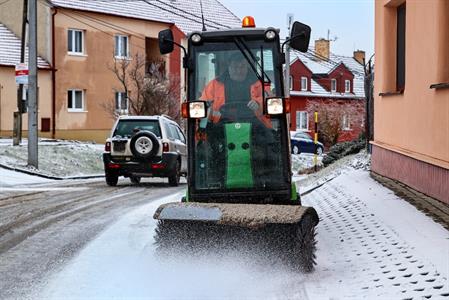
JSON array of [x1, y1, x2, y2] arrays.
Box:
[[0, 0, 240, 142]]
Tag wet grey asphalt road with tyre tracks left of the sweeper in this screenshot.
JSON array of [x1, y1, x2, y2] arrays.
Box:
[[0, 179, 185, 299]]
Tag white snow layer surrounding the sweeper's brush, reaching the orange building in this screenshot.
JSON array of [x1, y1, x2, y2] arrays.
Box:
[[40, 170, 449, 300]]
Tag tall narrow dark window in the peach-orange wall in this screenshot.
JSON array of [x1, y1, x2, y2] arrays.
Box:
[[396, 3, 405, 91]]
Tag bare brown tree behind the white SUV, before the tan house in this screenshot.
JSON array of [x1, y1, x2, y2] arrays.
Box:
[[102, 54, 180, 121]]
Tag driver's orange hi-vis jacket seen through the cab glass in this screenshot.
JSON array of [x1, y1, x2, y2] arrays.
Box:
[[200, 79, 272, 128]]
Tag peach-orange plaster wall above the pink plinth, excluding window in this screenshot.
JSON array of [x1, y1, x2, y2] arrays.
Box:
[[374, 0, 449, 169]]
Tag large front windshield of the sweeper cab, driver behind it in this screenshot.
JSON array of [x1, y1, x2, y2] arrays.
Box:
[[191, 41, 289, 190]]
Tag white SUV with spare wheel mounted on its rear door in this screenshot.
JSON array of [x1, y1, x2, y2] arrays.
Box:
[[103, 116, 187, 186]]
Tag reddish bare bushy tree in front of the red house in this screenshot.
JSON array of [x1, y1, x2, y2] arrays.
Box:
[[306, 99, 363, 146]]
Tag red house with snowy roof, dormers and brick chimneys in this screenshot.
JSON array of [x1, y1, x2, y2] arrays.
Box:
[[290, 39, 365, 142]]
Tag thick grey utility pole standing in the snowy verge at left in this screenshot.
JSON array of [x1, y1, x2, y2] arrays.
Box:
[[28, 0, 38, 169]]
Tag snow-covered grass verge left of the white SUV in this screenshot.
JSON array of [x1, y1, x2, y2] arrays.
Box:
[[0, 139, 104, 177]]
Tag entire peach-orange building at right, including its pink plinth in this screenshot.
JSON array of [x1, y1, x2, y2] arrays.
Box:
[[372, 0, 449, 204]]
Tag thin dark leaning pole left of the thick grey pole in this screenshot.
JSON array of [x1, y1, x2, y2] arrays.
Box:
[[13, 0, 28, 146]]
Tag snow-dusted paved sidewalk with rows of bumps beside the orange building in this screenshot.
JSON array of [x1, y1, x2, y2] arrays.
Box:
[[303, 170, 449, 299]]
